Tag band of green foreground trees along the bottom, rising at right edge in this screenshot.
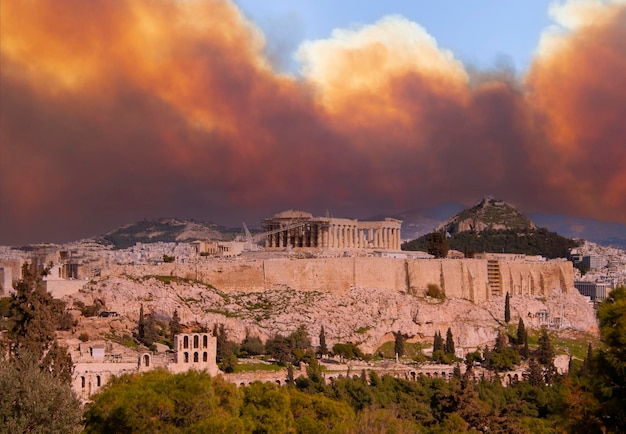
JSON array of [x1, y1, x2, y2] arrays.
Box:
[[85, 288, 626, 434]]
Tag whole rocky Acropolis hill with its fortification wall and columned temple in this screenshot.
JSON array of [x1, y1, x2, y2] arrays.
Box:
[[0, 211, 597, 360]]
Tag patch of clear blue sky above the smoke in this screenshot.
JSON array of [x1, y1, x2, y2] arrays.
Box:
[[236, 0, 553, 73]]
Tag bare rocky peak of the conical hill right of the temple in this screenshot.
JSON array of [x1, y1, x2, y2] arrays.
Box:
[[437, 196, 537, 234]]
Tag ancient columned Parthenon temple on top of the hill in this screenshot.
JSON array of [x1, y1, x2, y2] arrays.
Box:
[[264, 210, 402, 250]]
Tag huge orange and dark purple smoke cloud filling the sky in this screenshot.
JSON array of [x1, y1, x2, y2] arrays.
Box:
[[0, 0, 626, 244]]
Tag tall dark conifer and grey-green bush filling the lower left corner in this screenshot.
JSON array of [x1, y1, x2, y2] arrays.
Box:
[[0, 263, 82, 433]]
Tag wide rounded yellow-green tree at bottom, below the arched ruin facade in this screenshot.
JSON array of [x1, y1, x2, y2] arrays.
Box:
[[85, 369, 244, 434]]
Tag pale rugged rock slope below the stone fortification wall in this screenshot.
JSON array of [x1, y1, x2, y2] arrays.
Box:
[[67, 276, 597, 353]]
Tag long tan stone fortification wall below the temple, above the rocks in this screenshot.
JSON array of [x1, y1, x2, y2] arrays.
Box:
[[106, 257, 574, 302]]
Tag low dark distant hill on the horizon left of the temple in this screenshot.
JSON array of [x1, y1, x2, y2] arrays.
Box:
[[96, 218, 241, 249]]
